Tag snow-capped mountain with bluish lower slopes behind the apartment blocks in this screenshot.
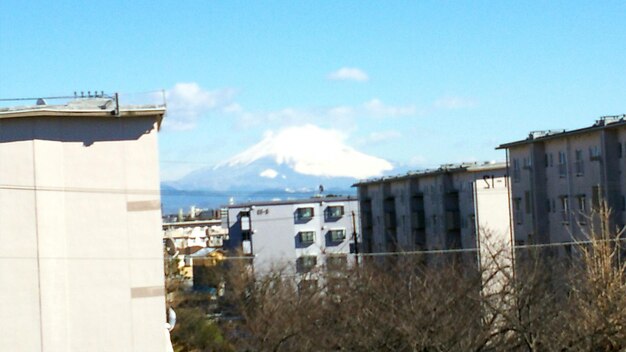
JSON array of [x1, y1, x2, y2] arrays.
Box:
[[163, 125, 393, 213]]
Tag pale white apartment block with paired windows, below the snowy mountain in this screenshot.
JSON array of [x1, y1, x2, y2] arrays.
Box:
[[224, 197, 359, 273]]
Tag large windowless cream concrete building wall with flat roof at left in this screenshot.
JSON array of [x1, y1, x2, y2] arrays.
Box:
[[0, 98, 165, 352]]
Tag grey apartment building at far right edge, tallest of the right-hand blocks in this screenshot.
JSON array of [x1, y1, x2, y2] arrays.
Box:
[[498, 115, 626, 251]]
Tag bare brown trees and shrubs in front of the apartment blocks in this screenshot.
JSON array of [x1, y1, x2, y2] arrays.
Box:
[[168, 210, 626, 351]]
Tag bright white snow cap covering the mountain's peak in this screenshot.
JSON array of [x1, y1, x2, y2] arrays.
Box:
[[220, 124, 393, 179]]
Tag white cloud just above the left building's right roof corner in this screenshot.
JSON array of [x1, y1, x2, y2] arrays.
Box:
[[164, 82, 237, 130]]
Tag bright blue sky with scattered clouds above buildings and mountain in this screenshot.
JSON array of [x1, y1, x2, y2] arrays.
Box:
[[0, 0, 626, 181]]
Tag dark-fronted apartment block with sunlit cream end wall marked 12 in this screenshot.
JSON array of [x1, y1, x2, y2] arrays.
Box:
[[354, 163, 510, 262]]
